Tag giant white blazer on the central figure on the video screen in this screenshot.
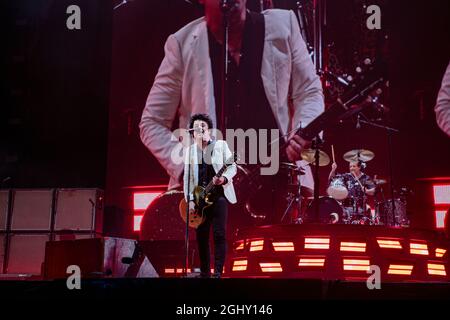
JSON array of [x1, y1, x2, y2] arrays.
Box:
[[139, 9, 324, 188]]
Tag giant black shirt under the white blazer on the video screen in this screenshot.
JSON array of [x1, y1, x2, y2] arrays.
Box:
[[208, 11, 278, 134]]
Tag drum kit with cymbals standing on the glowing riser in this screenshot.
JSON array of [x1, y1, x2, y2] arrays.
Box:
[[296, 146, 409, 227]]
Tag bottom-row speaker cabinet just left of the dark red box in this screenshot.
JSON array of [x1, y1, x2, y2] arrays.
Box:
[[5, 233, 50, 275]]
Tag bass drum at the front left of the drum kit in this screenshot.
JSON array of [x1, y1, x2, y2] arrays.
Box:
[[306, 197, 344, 224]]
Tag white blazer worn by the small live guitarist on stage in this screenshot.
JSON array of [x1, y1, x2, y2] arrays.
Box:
[[183, 140, 237, 203]]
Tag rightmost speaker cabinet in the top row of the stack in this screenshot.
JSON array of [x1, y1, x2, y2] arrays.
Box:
[[55, 189, 103, 234]]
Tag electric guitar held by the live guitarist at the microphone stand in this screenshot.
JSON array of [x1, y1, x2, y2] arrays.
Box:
[[179, 153, 238, 229]]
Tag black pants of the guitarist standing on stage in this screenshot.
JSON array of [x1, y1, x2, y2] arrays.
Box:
[[197, 196, 228, 275]]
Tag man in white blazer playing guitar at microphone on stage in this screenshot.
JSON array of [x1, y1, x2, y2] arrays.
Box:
[[180, 114, 236, 278]]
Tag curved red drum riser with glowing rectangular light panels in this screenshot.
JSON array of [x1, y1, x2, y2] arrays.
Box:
[[228, 224, 450, 282]]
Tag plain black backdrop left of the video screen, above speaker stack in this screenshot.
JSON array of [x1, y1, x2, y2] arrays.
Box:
[[0, 0, 112, 188]]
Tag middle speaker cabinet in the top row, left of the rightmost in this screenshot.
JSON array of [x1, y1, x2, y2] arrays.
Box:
[[11, 189, 53, 231]]
